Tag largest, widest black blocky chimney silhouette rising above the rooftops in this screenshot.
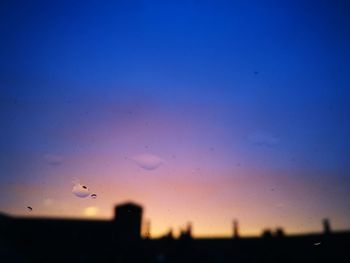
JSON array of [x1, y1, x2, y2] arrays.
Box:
[[114, 202, 142, 240]]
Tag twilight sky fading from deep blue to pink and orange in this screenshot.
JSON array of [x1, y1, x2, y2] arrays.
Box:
[[0, 0, 350, 237]]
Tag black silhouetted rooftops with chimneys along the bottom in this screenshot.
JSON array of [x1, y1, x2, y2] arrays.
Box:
[[0, 202, 350, 262]]
